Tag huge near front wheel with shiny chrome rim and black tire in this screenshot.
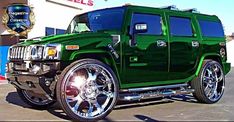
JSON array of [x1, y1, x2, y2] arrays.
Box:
[[56, 59, 119, 121]]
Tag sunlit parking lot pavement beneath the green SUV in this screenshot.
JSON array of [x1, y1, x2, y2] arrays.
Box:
[[0, 68, 234, 121]]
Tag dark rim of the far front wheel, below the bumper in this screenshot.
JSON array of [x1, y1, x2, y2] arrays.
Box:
[[22, 90, 53, 106]]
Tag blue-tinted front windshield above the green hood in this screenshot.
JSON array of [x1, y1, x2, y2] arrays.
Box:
[[67, 7, 125, 33]]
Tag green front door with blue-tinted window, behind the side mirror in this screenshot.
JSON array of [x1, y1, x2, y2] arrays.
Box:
[[123, 13, 168, 86]]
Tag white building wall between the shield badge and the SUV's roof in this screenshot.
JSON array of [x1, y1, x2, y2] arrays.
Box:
[[28, 0, 93, 38]]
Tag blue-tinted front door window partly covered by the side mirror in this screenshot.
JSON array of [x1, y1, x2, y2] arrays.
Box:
[[130, 14, 162, 35]]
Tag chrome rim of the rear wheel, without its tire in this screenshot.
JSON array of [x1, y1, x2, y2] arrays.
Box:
[[202, 63, 225, 102]]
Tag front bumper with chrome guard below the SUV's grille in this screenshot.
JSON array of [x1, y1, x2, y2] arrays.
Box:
[[5, 62, 60, 96]]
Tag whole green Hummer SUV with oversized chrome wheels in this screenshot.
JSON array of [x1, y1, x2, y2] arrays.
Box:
[[6, 5, 230, 121]]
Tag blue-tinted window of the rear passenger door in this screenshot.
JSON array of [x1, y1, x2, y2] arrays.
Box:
[[170, 17, 193, 36]]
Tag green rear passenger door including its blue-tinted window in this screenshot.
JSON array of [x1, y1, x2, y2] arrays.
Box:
[[167, 13, 200, 80]]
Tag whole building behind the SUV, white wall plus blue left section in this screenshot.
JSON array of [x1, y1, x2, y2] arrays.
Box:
[[0, 0, 94, 79]]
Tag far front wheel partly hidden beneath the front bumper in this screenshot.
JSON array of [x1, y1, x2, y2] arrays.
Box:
[[16, 89, 56, 110]]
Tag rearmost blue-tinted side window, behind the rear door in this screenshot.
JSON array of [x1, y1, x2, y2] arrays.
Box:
[[199, 20, 224, 37]]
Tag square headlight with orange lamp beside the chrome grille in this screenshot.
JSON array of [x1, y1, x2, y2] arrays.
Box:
[[43, 44, 61, 60]]
